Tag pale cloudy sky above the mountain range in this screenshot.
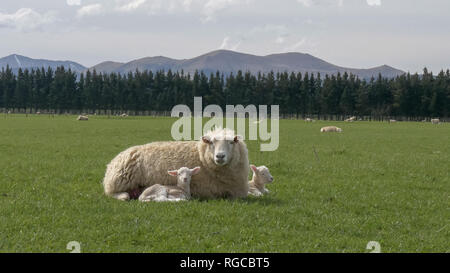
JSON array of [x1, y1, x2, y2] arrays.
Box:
[[0, 0, 450, 73]]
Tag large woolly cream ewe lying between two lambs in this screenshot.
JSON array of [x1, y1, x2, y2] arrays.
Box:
[[103, 128, 249, 200]]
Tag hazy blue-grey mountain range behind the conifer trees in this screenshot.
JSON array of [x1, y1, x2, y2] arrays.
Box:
[[0, 50, 405, 79]]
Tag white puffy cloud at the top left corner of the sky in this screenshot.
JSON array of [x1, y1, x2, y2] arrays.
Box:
[[0, 8, 55, 31]]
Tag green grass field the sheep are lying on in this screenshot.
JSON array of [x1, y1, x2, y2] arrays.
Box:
[[0, 115, 450, 252]]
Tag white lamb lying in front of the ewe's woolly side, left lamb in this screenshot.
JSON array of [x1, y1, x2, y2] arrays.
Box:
[[139, 167, 200, 202]]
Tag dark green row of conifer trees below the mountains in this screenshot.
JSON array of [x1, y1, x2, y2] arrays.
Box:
[[0, 67, 450, 117]]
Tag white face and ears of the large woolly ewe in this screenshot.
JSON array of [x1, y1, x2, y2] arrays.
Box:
[[202, 135, 241, 166]]
